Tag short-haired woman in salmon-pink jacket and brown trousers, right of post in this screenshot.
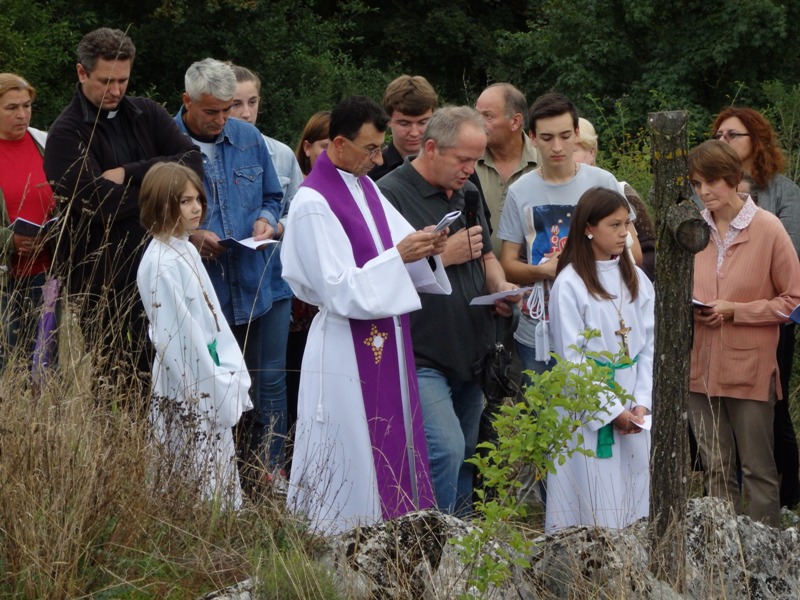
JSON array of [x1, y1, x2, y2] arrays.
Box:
[[689, 141, 800, 526]]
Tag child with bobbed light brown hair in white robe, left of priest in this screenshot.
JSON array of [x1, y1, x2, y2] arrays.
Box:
[[137, 163, 252, 508]]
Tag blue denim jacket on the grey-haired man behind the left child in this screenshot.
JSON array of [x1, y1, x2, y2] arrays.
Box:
[[175, 108, 283, 325]]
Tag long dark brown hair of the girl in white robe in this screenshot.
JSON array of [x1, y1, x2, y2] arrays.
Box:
[[556, 187, 639, 300]]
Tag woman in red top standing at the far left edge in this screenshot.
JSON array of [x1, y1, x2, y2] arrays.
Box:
[[0, 73, 54, 365]]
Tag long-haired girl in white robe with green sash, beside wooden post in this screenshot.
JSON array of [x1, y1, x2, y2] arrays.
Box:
[[545, 188, 655, 532]]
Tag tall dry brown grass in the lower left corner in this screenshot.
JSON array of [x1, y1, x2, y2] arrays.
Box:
[[0, 298, 335, 599]]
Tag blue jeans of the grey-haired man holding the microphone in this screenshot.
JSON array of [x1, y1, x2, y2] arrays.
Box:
[[417, 368, 484, 514]]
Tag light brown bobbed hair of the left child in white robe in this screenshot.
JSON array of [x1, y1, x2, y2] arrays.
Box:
[[139, 162, 208, 237]]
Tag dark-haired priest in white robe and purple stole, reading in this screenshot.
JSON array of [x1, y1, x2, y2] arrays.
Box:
[[281, 96, 450, 534]]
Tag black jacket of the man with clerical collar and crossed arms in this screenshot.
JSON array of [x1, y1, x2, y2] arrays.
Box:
[[44, 85, 203, 293]]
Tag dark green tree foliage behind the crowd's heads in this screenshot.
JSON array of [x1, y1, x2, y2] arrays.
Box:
[[0, 0, 800, 173]]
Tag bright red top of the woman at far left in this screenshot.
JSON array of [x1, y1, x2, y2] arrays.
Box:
[[0, 132, 55, 277]]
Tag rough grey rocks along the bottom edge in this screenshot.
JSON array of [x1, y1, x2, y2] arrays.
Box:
[[206, 498, 800, 600]]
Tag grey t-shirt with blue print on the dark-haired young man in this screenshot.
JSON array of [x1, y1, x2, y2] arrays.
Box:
[[498, 165, 619, 348]]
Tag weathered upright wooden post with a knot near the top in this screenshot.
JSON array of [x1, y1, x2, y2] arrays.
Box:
[[649, 111, 709, 592]]
